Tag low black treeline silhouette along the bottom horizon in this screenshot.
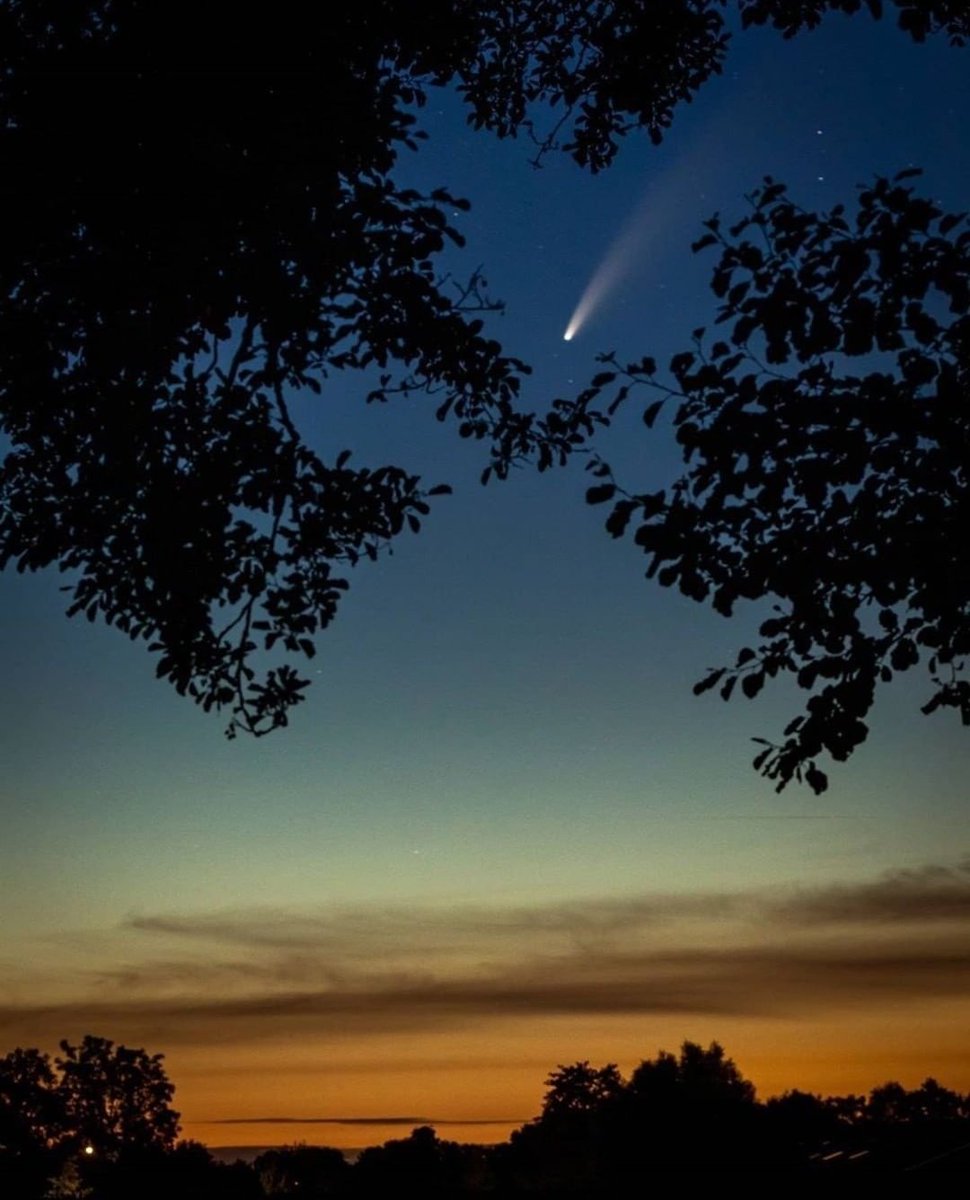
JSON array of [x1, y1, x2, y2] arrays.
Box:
[[0, 1036, 970, 1200]]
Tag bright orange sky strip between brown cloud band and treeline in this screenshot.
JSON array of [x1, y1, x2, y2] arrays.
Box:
[[159, 1002, 970, 1150]]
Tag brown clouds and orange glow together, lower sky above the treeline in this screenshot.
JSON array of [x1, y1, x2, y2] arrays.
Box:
[[7, 862, 970, 1148]]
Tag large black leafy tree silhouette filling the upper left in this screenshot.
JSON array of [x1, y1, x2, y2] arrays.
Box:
[[0, 0, 970, 748]]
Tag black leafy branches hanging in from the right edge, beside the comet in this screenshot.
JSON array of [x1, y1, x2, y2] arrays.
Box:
[[587, 172, 970, 792]]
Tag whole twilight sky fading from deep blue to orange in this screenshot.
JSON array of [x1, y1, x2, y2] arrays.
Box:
[[0, 17, 970, 1146]]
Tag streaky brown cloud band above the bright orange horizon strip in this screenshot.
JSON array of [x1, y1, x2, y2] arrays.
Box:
[[0, 863, 970, 1045]]
